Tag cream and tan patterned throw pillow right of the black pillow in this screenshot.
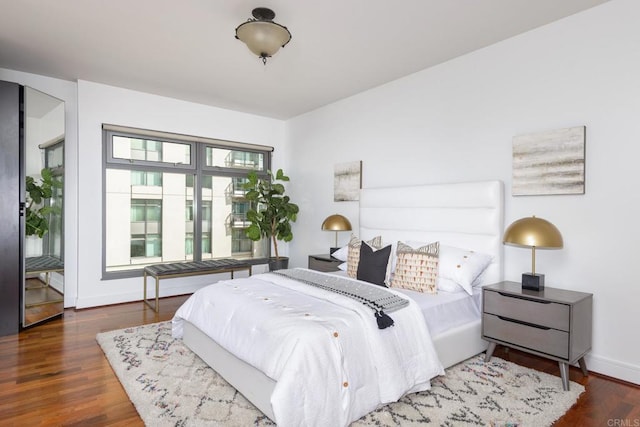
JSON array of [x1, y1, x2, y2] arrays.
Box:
[[391, 242, 440, 294]]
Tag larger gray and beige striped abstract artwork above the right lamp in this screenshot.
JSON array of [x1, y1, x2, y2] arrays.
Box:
[[512, 126, 586, 196]]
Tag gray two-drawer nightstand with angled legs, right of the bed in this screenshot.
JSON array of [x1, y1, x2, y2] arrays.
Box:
[[482, 282, 593, 390]]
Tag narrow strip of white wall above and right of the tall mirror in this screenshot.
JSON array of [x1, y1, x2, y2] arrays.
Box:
[[0, 68, 78, 307]]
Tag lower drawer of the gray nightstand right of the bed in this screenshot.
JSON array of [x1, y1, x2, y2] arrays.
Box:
[[482, 313, 569, 359]]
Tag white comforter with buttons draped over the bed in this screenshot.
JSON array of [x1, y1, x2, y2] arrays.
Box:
[[173, 273, 444, 426]]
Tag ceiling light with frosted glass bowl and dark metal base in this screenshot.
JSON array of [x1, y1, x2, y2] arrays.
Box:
[[236, 7, 291, 65]]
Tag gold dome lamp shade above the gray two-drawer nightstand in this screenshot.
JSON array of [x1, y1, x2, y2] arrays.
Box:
[[503, 216, 563, 249]]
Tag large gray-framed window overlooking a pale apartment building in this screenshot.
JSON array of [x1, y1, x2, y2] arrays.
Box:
[[103, 125, 271, 278]]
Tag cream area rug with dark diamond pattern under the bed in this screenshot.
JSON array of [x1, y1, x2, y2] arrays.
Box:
[[96, 322, 584, 427]]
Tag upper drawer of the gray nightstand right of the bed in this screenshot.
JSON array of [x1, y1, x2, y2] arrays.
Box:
[[484, 291, 570, 332]]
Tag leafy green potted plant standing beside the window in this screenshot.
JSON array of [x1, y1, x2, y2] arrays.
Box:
[[244, 169, 299, 271]]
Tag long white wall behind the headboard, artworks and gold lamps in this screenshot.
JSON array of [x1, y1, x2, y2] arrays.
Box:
[[287, 0, 640, 383]]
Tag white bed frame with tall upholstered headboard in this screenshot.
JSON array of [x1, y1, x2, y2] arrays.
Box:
[[183, 181, 504, 420]]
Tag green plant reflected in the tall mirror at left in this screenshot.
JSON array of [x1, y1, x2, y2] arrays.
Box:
[[25, 168, 62, 238]]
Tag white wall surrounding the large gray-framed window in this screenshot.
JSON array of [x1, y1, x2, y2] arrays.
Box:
[[76, 80, 286, 308]]
